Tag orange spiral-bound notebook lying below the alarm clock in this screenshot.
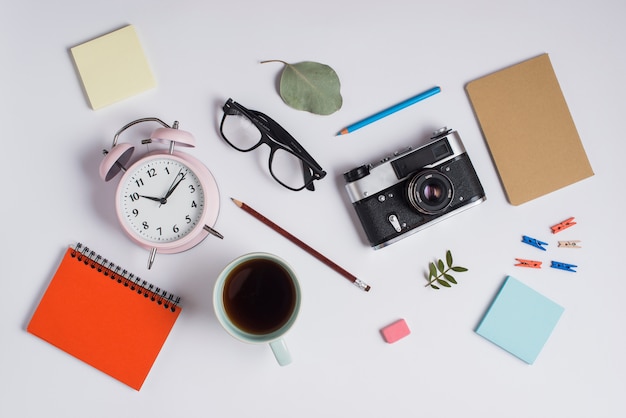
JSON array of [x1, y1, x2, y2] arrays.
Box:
[[27, 244, 182, 390]]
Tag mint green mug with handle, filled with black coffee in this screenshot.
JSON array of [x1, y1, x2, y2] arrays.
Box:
[[213, 252, 301, 366]]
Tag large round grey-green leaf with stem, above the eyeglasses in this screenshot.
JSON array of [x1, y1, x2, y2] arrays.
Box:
[[261, 60, 343, 115]]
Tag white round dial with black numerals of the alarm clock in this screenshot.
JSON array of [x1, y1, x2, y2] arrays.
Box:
[[117, 155, 207, 248]]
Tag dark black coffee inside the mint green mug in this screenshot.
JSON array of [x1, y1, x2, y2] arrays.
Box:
[[223, 258, 297, 335]]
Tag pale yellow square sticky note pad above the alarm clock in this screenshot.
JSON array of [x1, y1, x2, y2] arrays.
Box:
[[71, 25, 156, 110]]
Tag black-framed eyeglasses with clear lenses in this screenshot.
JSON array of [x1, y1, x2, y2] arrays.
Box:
[[220, 99, 326, 191]]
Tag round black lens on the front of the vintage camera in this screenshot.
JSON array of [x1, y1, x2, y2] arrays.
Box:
[[407, 170, 453, 215]]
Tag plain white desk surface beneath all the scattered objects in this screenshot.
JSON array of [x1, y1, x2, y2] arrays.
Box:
[[0, 0, 626, 418]]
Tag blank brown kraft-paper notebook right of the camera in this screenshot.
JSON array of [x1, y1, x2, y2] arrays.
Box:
[[466, 54, 593, 205]]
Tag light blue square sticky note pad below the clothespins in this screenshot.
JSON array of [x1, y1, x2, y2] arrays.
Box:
[[476, 276, 564, 364]]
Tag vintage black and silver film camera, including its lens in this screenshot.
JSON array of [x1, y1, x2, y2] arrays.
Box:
[[343, 128, 486, 249]]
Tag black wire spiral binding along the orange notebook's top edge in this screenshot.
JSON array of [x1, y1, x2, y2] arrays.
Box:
[[71, 242, 180, 312]]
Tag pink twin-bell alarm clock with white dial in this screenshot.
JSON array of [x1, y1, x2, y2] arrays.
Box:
[[100, 118, 223, 268]]
